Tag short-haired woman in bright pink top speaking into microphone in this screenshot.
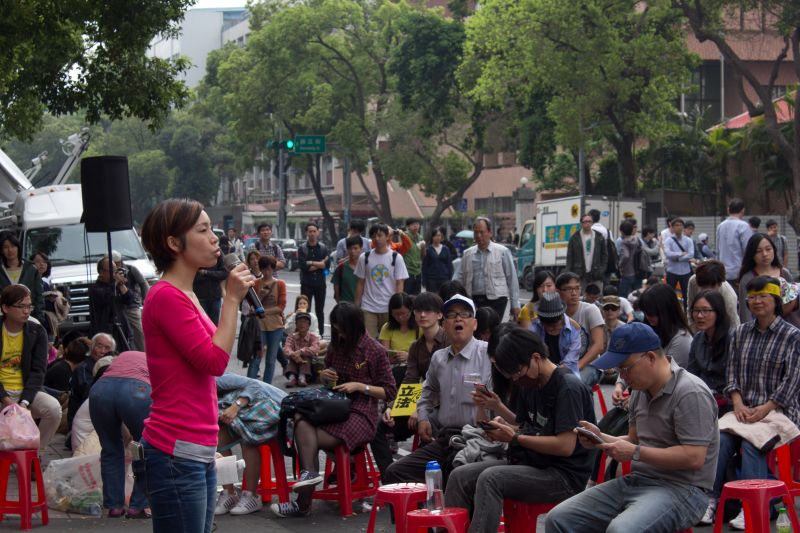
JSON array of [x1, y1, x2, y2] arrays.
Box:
[[134, 199, 254, 533]]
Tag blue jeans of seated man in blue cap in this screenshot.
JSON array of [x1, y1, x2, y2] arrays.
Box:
[[545, 474, 708, 533]]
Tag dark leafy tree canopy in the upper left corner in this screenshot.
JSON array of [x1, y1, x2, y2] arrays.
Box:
[[0, 0, 194, 139]]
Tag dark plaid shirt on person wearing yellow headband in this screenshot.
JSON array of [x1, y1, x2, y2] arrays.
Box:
[[725, 317, 800, 425]]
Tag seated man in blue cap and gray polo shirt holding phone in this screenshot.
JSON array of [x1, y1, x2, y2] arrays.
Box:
[[546, 322, 719, 533]]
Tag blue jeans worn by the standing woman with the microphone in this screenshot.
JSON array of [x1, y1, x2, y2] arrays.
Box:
[[134, 439, 217, 533]]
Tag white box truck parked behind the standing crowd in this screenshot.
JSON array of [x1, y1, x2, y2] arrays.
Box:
[[521, 196, 644, 279]]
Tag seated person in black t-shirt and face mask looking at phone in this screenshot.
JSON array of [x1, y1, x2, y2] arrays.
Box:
[[444, 324, 594, 533]]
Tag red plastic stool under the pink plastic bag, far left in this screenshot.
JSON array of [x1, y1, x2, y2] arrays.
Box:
[[0, 450, 49, 530]]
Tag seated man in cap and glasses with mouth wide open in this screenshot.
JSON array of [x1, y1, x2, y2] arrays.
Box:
[[384, 294, 492, 483]]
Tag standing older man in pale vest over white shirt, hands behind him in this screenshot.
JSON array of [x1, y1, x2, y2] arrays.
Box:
[[458, 217, 520, 320]]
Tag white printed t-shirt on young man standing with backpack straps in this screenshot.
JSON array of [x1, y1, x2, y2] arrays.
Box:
[[356, 250, 408, 313]]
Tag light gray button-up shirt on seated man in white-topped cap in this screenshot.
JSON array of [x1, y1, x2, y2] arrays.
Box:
[[417, 339, 492, 428]]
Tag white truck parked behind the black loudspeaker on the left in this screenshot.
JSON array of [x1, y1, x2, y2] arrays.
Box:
[[0, 144, 157, 331]]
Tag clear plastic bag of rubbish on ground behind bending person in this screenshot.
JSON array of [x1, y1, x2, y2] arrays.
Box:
[[42, 454, 103, 516]]
